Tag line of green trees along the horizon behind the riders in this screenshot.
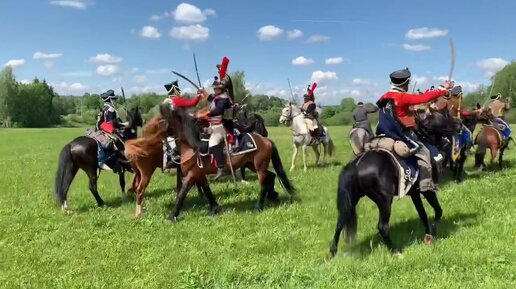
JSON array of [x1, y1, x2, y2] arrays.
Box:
[[0, 63, 516, 127]]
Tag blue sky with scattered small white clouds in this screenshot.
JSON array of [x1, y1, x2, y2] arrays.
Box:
[[0, 0, 516, 104]]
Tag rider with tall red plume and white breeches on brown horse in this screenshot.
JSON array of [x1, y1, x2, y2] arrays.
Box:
[[196, 57, 233, 180]]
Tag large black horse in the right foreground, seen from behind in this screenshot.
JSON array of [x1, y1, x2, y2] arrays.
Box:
[[330, 110, 461, 257]]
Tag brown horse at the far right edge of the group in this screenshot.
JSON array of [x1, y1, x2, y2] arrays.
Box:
[[475, 109, 509, 170]]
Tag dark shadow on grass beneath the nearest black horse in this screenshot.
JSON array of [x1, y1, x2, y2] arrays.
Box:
[[345, 213, 478, 257]]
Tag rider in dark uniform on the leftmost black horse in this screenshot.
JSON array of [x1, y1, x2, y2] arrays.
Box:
[[96, 89, 129, 171]]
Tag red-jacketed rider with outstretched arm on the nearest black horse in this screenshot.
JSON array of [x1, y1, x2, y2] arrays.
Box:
[[377, 68, 450, 192]]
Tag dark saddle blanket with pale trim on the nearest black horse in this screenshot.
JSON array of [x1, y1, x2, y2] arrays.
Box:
[[357, 148, 419, 198]]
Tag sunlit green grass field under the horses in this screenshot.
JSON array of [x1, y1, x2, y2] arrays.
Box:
[[0, 127, 516, 289]]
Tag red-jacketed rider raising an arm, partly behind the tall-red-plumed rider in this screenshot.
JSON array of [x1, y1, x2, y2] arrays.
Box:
[[163, 80, 207, 170]]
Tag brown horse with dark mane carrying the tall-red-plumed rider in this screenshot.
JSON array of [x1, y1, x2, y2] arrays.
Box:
[[160, 105, 295, 221]]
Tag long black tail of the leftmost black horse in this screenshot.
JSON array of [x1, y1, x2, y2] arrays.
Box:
[[55, 144, 74, 206]]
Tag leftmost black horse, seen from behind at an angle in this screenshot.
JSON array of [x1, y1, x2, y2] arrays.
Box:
[[55, 107, 143, 211]]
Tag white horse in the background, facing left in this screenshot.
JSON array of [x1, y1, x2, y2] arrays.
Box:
[[279, 104, 335, 172]]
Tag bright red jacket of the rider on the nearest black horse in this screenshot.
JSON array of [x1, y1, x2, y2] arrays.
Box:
[[378, 89, 447, 128]]
